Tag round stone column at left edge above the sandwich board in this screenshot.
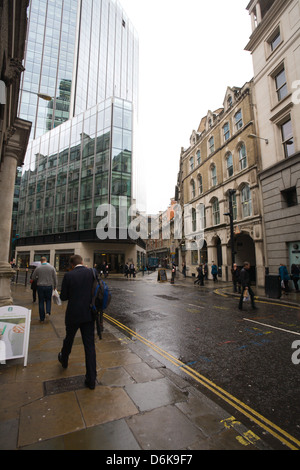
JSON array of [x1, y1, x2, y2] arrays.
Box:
[[0, 153, 17, 307]]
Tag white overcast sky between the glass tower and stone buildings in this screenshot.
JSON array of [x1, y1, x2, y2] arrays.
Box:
[[120, 0, 253, 214]]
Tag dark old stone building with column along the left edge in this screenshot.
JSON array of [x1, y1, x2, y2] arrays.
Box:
[[0, 0, 31, 307]]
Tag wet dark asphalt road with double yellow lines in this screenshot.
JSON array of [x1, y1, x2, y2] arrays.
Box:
[[106, 274, 300, 448]]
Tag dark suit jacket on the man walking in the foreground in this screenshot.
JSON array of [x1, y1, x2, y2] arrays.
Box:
[[60, 266, 94, 325]]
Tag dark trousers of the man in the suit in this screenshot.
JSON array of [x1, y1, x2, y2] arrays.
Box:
[[61, 321, 97, 384]]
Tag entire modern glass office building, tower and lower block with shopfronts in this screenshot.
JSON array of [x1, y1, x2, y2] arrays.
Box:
[[17, 0, 144, 271]]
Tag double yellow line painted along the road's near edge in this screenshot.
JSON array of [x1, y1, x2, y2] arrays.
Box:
[[104, 313, 300, 450]]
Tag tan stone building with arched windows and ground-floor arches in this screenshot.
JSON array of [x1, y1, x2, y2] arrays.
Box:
[[177, 81, 265, 285]]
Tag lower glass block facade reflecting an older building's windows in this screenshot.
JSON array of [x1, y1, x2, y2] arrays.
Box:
[[18, 98, 133, 237]]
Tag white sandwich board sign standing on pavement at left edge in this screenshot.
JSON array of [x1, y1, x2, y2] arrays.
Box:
[[0, 305, 31, 367]]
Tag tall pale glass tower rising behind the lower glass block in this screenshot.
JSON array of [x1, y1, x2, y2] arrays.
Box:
[[19, 0, 138, 138]]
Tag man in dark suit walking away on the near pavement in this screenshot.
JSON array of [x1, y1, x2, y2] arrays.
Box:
[[58, 255, 97, 390]]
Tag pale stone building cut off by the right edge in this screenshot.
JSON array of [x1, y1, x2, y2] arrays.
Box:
[[246, 0, 300, 274]]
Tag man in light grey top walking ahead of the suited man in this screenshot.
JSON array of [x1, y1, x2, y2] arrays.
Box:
[[32, 256, 57, 323]]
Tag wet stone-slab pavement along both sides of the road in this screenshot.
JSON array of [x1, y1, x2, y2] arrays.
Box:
[[0, 273, 299, 454]]
